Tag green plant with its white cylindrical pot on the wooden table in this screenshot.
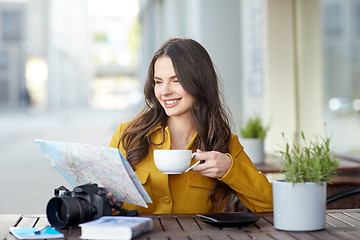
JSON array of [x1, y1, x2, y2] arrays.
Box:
[[273, 132, 339, 231]]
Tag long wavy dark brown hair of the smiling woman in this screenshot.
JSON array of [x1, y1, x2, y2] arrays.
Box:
[[119, 38, 231, 202]]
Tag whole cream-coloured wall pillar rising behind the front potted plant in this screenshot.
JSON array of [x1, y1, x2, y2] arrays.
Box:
[[264, 0, 323, 152]]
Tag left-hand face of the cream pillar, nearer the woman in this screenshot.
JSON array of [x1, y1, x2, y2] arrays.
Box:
[[264, 0, 298, 151]]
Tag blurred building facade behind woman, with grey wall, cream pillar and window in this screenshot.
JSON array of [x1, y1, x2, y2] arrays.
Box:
[[140, 0, 360, 157]]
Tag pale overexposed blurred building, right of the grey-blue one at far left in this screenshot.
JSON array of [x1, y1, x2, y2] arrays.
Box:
[[25, 0, 92, 109]]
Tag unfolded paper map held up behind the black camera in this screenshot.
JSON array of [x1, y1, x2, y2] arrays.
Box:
[[36, 140, 152, 208]]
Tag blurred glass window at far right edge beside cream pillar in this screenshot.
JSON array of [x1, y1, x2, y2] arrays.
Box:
[[321, 0, 360, 160]]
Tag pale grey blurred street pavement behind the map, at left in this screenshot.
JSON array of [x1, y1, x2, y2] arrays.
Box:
[[0, 108, 135, 213]]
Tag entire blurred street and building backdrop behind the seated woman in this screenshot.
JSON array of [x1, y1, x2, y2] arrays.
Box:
[[0, 0, 360, 214]]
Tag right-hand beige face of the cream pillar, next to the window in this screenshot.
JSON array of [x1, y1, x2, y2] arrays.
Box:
[[296, 0, 325, 136]]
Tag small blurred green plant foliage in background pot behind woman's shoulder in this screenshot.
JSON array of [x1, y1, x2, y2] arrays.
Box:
[[240, 116, 270, 140]]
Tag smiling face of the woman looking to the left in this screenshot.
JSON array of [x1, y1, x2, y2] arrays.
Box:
[[154, 56, 194, 117]]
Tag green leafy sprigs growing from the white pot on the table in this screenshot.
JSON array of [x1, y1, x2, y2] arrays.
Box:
[[279, 132, 339, 183]]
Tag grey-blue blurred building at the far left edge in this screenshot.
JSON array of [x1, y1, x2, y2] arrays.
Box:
[[0, 1, 29, 107]]
